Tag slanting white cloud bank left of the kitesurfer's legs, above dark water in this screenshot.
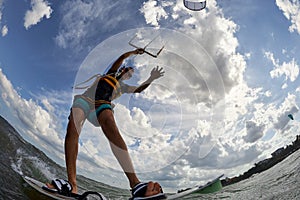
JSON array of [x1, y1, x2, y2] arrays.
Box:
[[0, 69, 64, 163]]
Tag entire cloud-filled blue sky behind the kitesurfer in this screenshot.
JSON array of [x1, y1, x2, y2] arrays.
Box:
[[0, 0, 300, 192]]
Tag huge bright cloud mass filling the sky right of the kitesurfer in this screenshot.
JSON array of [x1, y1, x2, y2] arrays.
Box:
[[65, 0, 278, 188]]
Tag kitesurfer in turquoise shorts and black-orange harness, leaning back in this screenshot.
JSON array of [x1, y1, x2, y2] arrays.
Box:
[[48, 49, 164, 199]]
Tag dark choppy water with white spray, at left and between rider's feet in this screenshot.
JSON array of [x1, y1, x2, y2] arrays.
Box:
[[0, 116, 130, 200]]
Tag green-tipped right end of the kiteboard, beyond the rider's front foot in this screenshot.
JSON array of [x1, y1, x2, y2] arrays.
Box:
[[167, 174, 224, 200]]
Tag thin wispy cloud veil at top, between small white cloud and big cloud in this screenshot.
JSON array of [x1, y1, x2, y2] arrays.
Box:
[[55, 0, 140, 51]]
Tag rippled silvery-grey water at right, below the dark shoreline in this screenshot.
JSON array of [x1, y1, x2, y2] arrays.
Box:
[[184, 150, 300, 200]]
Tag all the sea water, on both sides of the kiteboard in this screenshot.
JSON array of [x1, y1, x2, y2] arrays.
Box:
[[0, 116, 300, 200]]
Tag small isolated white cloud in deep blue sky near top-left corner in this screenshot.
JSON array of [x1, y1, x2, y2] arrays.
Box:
[[24, 0, 53, 29]]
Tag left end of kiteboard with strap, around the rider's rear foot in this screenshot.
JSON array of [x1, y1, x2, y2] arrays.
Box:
[[23, 176, 107, 200]]
